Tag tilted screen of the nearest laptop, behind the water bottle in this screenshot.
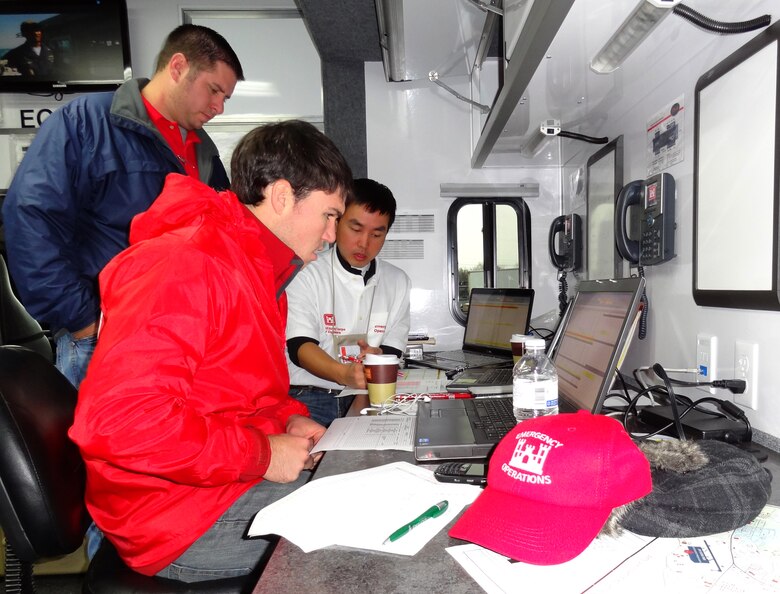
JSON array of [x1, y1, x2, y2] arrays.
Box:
[[551, 278, 644, 413]]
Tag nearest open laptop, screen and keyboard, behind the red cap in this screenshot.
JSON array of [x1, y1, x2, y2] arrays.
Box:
[[414, 278, 644, 462]]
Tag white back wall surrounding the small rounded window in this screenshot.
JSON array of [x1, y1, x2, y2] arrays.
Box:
[[366, 62, 560, 348]]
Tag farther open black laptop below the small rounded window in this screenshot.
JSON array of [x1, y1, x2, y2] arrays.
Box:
[[407, 288, 534, 371]]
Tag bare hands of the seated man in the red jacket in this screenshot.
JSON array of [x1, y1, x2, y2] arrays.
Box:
[[263, 415, 325, 483]]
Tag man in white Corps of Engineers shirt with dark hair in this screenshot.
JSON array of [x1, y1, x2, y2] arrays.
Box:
[[287, 178, 412, 426]]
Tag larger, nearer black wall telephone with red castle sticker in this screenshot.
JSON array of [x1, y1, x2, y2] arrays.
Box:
[[615, 173, 676, 266]]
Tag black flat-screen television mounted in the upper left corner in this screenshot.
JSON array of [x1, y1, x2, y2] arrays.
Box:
[[0, 0, 132, 93]]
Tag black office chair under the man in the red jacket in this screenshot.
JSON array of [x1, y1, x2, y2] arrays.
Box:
[[0, 345, 247, 594]]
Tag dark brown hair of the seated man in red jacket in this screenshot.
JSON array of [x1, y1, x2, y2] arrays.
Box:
[[230, 120, 352, 204]]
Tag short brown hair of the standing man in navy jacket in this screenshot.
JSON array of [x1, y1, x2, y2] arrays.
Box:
[[156, 25, 244, 80]]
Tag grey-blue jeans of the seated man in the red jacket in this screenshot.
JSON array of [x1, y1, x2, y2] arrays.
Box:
[[157, 470, 311, 582]]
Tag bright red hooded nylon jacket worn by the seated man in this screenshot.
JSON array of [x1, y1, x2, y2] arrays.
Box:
[[70, 174, 308, 575]]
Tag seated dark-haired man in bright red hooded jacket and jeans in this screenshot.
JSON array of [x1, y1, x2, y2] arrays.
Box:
[[70, 121, 352, 581]]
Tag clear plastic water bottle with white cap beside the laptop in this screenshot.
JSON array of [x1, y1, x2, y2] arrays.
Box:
[[512, 338, 558, 422]]
